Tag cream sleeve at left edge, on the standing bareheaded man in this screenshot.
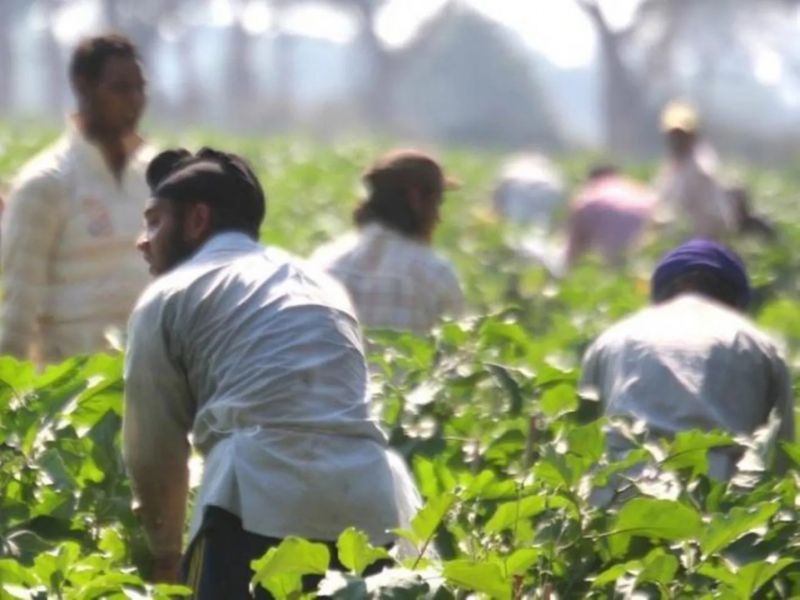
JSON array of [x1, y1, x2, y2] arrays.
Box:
[[0, 174, 63, 360]]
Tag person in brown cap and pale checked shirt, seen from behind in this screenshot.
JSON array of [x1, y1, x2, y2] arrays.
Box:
[[311, 150, 464, 334]]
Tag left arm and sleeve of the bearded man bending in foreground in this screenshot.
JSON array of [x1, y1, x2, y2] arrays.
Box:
[[122, 297, 194, 558]]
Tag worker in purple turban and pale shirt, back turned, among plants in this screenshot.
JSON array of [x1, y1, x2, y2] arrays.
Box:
[[581, 240, 794, 479]]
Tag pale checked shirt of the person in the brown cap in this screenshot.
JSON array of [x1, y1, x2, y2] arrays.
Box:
[[311, 223, 464, 334]]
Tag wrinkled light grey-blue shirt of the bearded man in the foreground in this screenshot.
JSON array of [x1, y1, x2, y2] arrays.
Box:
[[123, 233, 419, 555]]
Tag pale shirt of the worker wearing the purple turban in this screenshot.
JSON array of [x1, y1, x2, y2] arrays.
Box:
[[581, 294, 794, 473]]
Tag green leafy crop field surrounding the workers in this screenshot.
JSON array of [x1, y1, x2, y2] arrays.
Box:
[[0, 126, 800, 599]]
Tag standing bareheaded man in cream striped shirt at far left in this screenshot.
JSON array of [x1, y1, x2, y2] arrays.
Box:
[[0, 35, 154, 362]]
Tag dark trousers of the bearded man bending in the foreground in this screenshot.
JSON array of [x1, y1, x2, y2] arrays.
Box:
[[181, 506, 392, 600]]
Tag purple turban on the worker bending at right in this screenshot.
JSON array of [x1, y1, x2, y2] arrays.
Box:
[[650, 239, 750, 306]]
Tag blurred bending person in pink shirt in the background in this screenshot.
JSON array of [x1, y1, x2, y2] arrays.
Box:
[[566, 165, 655, 267]]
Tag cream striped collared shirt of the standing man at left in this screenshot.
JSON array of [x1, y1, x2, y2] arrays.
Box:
[[0, 125, 154, 362]]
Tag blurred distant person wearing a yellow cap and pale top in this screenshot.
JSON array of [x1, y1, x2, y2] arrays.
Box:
[[657, 102, 737, 239]]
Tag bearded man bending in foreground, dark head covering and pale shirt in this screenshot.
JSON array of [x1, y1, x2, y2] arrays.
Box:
[[123, 149, 418, 598]]
